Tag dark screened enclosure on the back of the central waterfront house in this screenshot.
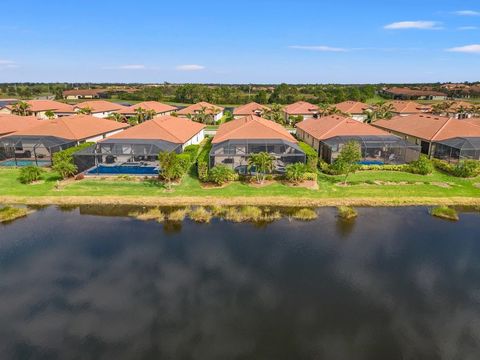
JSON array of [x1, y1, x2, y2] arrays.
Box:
[[210, 139, 305, 173]]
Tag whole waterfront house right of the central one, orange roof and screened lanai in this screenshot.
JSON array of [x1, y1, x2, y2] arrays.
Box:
[[297, 115, 420, 165]]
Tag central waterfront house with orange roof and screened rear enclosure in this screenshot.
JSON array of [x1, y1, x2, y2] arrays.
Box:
[[210, 115, 305, 173]]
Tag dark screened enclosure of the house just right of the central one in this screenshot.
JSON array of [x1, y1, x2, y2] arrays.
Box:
[[319, 135, 420, 165]]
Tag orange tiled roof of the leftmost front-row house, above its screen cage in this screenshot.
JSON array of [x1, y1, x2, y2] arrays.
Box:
[[12, 115, 129, 141]]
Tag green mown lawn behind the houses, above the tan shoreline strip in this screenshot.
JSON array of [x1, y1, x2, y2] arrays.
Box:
[[0, 168, 480, 202]]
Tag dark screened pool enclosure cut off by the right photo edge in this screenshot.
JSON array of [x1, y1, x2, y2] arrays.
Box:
[[433, 137, 480, 162]]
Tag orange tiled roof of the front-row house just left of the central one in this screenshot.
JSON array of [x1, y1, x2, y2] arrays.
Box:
[[109, 116, 205, 144]]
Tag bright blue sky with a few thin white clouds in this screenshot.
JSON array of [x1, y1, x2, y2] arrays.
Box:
[[0, 0, 480, 83]]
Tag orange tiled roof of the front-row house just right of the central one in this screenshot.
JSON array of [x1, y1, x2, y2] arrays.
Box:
[[297, 115, 390, 140]]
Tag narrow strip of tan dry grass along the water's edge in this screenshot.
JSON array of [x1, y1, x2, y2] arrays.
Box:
[[0, 196, 480, 207]]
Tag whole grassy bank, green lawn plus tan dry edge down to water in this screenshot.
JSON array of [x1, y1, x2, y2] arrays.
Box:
[[0, 168, 480, 206]]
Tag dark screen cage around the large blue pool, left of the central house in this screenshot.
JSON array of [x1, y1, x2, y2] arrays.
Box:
[[73, 139, 182, 172]]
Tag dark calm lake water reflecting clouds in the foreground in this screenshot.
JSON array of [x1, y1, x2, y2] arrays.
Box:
[[0, 207, 480, 360]]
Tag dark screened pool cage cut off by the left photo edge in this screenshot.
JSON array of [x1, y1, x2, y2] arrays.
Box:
[[0, 136, 77, 166]]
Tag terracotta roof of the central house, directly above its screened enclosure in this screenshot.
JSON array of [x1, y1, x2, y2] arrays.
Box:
[[212, 115, 297, 144]]
